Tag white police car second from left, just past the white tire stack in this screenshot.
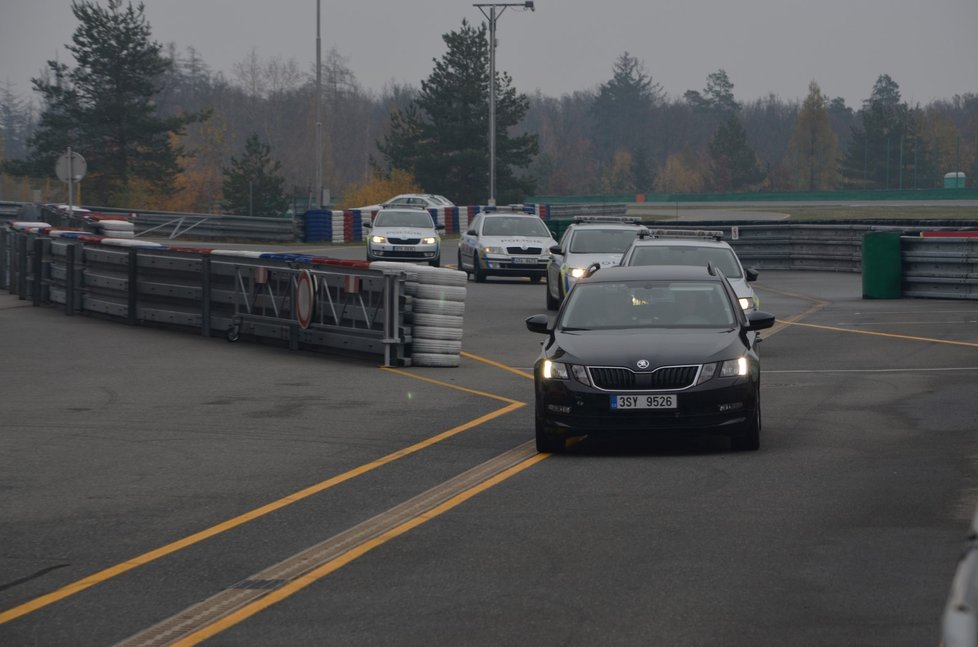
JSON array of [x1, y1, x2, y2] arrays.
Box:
[[458, 211, 557, 283]]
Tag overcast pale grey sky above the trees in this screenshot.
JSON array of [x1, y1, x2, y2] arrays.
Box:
[[0, 0, 978, 108]]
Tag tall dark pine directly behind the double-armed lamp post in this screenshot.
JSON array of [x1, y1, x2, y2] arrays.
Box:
[[378, 20, 537, 204]]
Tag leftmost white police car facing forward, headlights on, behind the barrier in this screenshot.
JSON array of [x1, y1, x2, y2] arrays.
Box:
[[363, 207, 445, 267]]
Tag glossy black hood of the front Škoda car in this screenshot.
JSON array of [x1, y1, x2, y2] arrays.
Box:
[[550, 328, 746, 369]]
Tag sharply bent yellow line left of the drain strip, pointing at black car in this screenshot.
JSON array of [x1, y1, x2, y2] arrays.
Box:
[[0, 369, 526, 625]]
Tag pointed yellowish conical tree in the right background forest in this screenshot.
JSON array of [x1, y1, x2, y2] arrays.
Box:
[[785, 81, 839, 191]]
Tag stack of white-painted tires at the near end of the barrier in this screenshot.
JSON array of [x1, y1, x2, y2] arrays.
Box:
[[370, 261, 467, 367]]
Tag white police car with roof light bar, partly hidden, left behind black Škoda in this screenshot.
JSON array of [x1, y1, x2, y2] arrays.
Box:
[[547, 216, 645, 310]]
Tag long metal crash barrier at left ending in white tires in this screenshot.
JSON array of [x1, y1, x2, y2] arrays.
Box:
[[0, 223, 466, 366]]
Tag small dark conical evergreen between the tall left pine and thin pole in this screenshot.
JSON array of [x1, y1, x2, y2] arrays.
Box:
[[223, 134, 289, 218]]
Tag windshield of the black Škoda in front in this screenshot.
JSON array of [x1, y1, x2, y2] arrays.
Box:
[[557, 281, 737, 330]]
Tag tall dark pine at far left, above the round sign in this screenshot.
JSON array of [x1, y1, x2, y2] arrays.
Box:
[[12, 0, 202, 205]]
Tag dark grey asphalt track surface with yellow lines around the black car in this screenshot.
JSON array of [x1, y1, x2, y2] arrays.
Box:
[[0, 244, 978, 647]]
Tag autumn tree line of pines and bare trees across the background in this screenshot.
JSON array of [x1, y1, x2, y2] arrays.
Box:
[[0, 0, 978, 215]]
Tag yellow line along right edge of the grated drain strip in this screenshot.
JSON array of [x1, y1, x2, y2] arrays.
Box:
[[171, 454, 550, 647]]
